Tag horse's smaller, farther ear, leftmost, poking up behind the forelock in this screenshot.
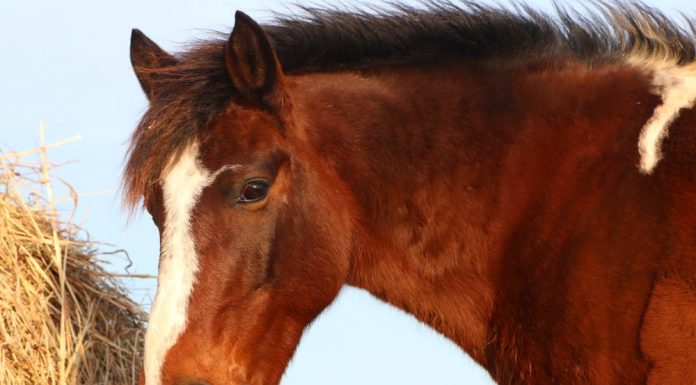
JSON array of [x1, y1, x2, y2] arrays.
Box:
[[131, 28, 177, 98]]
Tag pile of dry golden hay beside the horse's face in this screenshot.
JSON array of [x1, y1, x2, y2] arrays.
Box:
[[0, 130, 145, 385]]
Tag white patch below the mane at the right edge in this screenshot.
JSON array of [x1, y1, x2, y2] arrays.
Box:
[[631, 60, 696, 174]]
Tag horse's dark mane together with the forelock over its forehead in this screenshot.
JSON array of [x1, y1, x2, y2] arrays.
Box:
[[124, 0, 696, 207]]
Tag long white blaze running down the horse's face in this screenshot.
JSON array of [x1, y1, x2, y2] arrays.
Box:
[[144, 143, 239, 385]]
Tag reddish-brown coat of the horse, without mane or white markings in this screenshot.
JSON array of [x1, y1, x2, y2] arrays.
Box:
[[127, 1, 696, 385]]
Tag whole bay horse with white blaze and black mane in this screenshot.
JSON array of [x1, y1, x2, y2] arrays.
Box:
[[124, 1, 696, 385]]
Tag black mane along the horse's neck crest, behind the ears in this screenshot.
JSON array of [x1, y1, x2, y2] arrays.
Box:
[[270, 1, 696, 73]]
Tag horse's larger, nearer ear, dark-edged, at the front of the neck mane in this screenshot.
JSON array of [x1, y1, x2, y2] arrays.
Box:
[[225, 11, 284, 107]]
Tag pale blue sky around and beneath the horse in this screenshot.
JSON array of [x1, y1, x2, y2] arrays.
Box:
[[0, 0, 696, 385]]
